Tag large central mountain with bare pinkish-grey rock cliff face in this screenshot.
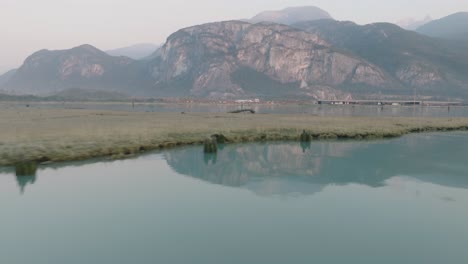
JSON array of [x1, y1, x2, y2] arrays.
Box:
[[150, 21, 393, 99]]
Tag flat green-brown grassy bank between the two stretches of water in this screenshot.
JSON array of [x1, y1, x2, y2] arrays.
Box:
[[0, 108, 468, 166]]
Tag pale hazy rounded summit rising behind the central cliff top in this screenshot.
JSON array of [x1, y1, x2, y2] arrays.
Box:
[[248, 6, 333, 25]]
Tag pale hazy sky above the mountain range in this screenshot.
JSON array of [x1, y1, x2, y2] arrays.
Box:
[[0, 0, 468, 73]]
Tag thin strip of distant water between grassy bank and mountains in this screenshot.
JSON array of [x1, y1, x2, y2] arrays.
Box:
[[0, 102, 468, 117]]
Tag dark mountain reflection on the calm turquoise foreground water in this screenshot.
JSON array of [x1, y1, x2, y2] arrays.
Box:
[[165, 133, 468, 195]]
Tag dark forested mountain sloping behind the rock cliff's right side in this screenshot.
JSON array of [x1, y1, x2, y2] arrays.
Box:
[[294, 20, 468, 97]]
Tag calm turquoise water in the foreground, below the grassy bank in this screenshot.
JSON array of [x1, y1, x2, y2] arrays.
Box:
[[0, 133, 468, 264]]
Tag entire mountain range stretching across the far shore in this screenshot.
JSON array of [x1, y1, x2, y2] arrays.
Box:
[[0, 7, 468, 99]]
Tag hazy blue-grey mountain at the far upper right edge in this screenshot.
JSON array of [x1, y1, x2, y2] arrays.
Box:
[[416, 12, 468, 40]]
